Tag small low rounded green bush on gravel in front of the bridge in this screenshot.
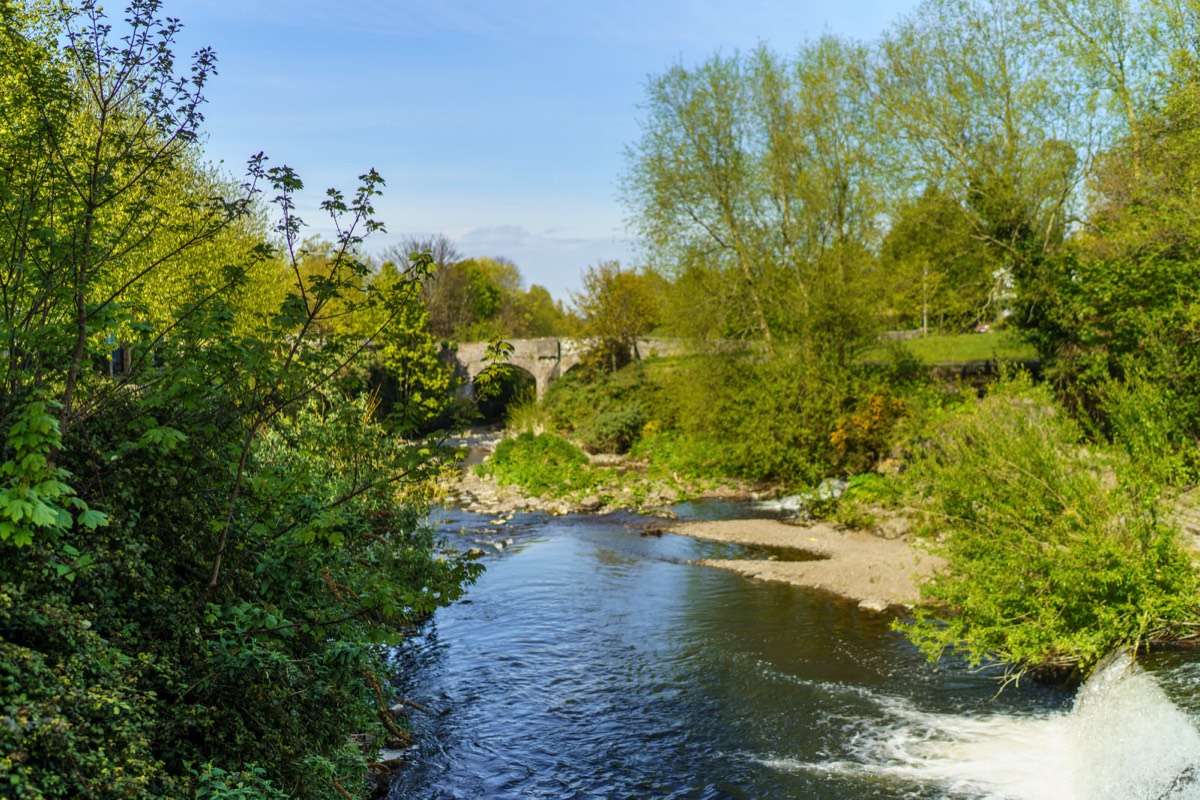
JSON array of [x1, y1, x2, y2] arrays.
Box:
[[482, 433, 599, 497]]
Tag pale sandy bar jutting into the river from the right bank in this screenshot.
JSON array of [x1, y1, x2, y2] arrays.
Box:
[[671, 519, 943, 610]]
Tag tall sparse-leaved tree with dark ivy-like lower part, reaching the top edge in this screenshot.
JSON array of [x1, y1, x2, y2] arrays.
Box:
[[875, 0, 1097, 327]]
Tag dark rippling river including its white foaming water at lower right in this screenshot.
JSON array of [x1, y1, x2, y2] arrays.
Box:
[[390, 504, 1200, 800]]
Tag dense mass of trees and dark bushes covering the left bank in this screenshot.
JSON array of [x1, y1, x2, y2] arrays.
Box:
[[0, 0, 479, 800]]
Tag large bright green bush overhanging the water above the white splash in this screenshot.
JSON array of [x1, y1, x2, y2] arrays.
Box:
[[904, 379, 1198, 675]]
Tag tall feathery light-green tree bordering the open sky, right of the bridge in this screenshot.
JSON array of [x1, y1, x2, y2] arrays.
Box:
[[624, 37, 883, 361]]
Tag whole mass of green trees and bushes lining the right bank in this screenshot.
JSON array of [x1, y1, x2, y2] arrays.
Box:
[[477, 0, 1200, 679]]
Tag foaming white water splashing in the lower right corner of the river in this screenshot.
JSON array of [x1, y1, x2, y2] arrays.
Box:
[[840, 652, 1200, 800]]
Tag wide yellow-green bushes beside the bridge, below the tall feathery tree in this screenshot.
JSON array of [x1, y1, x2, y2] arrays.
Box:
[[545, 351, 858, 483]]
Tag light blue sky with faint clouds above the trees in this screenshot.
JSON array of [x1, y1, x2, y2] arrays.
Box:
[[163, 0, 914, 300]]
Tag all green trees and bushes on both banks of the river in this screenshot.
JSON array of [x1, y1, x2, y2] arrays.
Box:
[[7, 0, 1200, 800]]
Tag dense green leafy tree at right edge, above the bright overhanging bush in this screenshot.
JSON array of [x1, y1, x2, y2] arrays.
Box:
[[1034, 55, 1200, 437]]
